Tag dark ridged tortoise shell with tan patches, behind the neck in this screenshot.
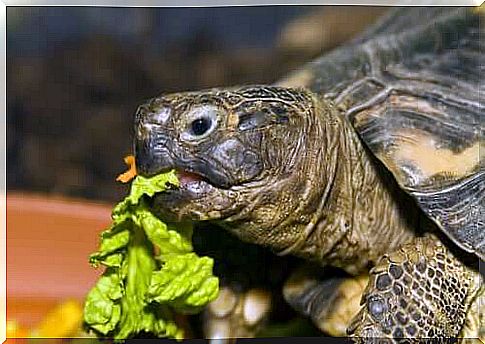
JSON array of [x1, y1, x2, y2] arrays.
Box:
[[280, 7, 485, 260]]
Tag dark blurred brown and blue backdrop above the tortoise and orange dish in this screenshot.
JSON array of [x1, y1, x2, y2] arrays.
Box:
[[7, 6, 379, 202]]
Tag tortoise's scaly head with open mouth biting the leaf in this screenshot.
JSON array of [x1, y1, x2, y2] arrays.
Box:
[[135, 86, 332, 250]]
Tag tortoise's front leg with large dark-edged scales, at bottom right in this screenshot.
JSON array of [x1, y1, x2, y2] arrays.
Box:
[[348, 237, 484, 342]]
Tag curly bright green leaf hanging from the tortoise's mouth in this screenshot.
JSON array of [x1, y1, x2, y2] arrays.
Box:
[[84, 171, 219, 339]]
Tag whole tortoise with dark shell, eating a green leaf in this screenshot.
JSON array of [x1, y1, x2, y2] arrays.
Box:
[[134, 7, 485, 342]]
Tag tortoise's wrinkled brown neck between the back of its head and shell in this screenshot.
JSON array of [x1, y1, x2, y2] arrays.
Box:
[[282, 104, 419, 274]]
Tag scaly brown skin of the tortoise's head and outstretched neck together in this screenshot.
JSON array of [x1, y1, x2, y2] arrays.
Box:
[[137, 87, 418, 274]]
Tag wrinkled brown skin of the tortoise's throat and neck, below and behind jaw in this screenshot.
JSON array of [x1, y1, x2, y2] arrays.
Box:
[[222, 92, 419, 274]]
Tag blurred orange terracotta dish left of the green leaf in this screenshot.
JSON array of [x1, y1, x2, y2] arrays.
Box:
[[7, 192, 112, 328]]
